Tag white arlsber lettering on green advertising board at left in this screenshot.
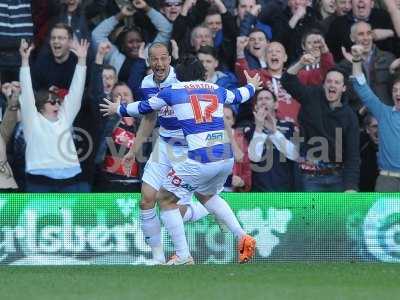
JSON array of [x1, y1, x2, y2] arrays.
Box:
[[0, 209, 149, 262]]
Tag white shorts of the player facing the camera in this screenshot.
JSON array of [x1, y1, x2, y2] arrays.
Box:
[[142, 137, 191, 204]]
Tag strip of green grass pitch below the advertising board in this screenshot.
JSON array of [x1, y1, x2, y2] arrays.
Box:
[[0, 263, 400, 300]]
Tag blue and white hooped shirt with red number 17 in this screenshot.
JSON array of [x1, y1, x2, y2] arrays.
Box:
[[118, 81, 255, 163]]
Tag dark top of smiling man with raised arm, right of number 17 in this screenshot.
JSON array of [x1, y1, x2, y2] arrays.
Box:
[[281, 73, 360, 190]]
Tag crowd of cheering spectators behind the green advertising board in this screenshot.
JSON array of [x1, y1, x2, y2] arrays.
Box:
[[0, 0, 400, 192]]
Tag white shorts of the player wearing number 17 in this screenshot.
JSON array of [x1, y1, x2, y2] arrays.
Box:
[[162, 158, 233, 199]]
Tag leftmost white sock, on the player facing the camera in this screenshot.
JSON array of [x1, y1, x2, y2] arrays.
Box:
[[140, 208, 165, 262]]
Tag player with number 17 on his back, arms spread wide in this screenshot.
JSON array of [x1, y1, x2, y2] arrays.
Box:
[[101, 56, 261, 265]]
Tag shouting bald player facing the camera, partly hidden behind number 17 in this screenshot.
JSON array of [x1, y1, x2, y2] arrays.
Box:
[[124, 43, 208, 264]]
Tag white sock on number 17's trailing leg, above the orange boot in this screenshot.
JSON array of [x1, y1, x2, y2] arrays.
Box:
[[204, 195, 246, 238]]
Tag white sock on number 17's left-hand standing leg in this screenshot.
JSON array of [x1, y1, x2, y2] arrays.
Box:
[[161, 208, 190, 259]]
